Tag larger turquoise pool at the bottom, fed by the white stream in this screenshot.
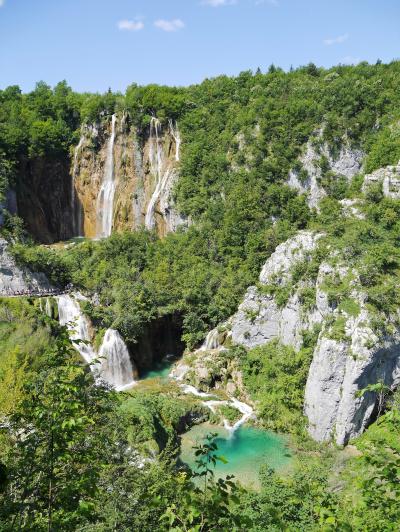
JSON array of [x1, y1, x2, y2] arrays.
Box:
[[180, 423, 291, 488]]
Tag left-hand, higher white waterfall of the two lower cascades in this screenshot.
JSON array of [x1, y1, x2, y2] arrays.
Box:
[[57, 293, 96, 364]]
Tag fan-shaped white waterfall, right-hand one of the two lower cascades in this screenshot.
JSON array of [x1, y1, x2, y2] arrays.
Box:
[[99, 329, 135, 391]]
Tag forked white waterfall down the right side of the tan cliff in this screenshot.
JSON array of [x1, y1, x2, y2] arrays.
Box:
[[144, 117, 181, 230]]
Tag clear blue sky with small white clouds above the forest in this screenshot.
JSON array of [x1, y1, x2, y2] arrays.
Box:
[[0, 0, 400, 92]]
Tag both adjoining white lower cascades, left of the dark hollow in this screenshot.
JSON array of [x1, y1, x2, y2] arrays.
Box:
[[57, 292, 135, 391]]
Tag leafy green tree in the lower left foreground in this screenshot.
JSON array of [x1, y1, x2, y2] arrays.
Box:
[[0, 328, 119, 531]]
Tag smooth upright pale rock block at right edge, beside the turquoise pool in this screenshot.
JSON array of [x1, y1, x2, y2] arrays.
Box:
[[304, 310, 400, 445]]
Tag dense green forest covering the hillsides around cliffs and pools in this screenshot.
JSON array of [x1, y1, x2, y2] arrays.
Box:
[[0, 62, 400, 531]]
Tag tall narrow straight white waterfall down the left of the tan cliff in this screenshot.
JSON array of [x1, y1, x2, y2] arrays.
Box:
[[96, 114, 117, 238]]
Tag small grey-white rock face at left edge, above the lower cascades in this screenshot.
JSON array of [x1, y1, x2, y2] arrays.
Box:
[[0, 238, 52, 296]]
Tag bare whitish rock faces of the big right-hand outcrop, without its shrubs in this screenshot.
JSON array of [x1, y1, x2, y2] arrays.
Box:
[[197, 231, 400, 445]]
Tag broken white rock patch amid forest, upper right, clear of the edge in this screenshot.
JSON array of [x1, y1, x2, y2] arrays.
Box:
[[288, 138, 364, 208]]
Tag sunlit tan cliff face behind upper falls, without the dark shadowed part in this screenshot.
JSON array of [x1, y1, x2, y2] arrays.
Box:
[[71, 114, 184, 237]]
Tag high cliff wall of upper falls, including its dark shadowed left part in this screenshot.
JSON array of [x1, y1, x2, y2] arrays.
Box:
[[15, 113, 185, 244]]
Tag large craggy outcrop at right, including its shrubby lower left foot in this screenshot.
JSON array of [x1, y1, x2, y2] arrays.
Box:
[[188, 231, 400, 445]]
